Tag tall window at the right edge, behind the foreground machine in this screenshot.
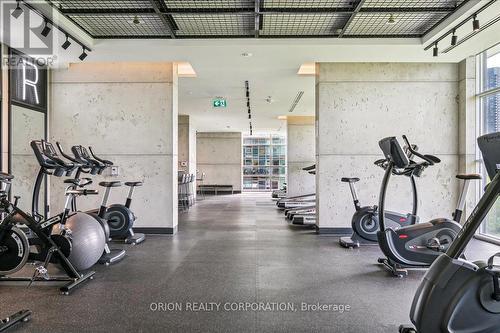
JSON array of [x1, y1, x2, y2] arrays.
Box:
[[477, 44, 500, 241]]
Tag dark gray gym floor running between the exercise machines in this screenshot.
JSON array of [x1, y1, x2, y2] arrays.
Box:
[[0, 194, 498, 333]]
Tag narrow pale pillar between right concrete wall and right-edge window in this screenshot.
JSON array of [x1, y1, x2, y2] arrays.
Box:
[[458, 57, 482, 216]]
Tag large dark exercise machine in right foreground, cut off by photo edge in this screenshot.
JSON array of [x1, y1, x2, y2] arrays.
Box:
[[399, 132, 500, 333]]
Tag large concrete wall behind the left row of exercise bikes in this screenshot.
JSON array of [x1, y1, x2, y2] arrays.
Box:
[[50, 63, 177, 232]]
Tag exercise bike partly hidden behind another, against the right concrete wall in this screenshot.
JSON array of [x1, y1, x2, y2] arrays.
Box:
[[339, 157, 419, 248]]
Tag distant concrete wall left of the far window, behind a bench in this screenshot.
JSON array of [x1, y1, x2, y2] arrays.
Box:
[[196, 132, 242, 191]]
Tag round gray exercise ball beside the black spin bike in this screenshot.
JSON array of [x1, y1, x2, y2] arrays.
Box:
[[53, 212, 106, 271]]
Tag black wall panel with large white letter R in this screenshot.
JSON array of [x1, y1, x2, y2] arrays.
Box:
[[9, 50, 47, 111]]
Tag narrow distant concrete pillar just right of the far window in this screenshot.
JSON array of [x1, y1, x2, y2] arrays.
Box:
[[287, 116, 316, 196]]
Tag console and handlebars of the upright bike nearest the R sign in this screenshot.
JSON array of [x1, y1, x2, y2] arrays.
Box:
[[30, 140, 80, 177]]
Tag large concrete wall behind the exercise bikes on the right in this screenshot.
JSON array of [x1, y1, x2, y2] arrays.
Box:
[[316, 63, 459, 232]]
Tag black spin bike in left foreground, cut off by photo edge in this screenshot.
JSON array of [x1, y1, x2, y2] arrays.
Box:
[[0, 170, 95, 295]]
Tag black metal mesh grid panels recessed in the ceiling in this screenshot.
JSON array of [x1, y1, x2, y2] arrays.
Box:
[[47, 0, 473, 39]]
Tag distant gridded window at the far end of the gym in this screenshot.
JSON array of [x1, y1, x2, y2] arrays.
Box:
[[243, 135, 286, 191]]
